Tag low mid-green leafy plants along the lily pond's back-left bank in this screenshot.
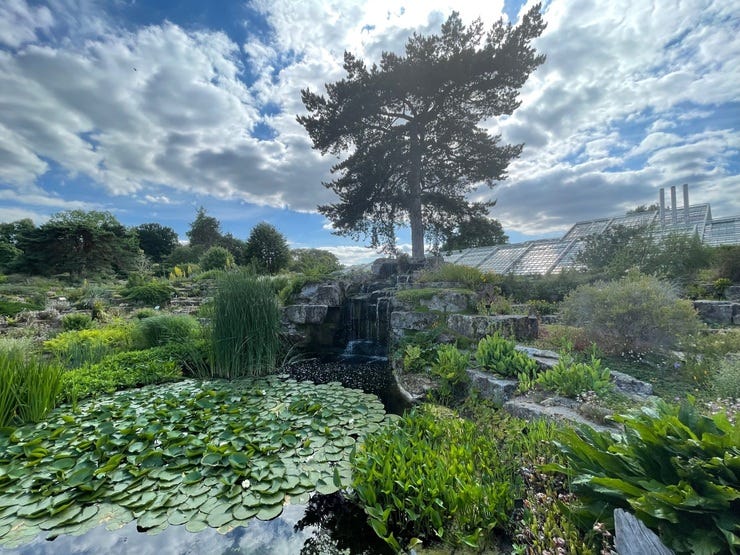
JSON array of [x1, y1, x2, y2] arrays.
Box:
[[62, 347, 182, 402]]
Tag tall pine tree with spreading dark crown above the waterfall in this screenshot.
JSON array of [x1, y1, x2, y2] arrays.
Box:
[[298, 5, 545, 261]]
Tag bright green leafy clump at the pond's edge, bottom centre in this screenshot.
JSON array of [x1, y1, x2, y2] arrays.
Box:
[[351, 406, 516, 551]]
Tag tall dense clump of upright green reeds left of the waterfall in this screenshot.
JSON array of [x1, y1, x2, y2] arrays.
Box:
[[212, 271, 280, 379]]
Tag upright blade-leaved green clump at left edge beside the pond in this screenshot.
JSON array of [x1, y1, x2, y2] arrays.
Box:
[[0, 346, 62, 428]]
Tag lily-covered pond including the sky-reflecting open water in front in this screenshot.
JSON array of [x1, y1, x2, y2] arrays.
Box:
[[0, 365, 404, 555]]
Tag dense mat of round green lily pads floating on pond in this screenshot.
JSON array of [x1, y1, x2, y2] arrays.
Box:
[[0, 376, 386, 547]]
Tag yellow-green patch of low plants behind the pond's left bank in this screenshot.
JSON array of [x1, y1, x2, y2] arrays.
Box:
[[44, 324, 132, 368]]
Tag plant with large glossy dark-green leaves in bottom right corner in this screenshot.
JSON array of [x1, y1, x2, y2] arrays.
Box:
[[551, 401, 740, 553]]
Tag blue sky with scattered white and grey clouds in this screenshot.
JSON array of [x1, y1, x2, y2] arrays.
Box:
[[0, 0, 740, 263]]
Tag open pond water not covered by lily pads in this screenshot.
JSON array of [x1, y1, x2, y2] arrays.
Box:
[[0, 360, 408, 555]]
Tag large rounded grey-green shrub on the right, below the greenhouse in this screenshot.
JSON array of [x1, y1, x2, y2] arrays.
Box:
[[561, 271, 700, 353]]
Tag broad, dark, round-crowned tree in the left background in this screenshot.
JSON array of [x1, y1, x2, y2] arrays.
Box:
[[18, 210, 140, 278]]
